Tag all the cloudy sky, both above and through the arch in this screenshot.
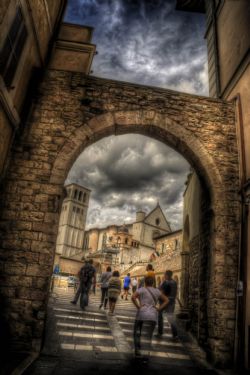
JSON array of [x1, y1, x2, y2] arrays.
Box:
[[65, 0, 208, 229]]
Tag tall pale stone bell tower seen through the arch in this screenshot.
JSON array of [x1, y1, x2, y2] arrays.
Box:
[[54, 184, 90, 274]]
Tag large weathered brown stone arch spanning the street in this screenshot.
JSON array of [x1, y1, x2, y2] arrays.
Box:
[[0, 70, 239, 362]]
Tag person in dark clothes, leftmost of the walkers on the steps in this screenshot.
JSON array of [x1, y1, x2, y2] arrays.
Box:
[[71, 259, 96, 310]]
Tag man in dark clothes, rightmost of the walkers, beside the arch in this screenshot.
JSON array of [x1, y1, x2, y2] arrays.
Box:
[[157, 270, 178, 340]]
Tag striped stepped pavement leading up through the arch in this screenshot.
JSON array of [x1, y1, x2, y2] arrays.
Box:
[[25, 288, 216, 375]]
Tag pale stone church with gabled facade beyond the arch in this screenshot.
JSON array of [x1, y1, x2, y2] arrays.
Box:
[[84, 204, 171, 271]]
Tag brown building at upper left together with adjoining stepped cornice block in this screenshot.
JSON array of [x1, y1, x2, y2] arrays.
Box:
[[0, 0, 95, 184]]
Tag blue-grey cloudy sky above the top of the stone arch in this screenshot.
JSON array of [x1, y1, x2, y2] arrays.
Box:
[[66, 0, 207, 94]]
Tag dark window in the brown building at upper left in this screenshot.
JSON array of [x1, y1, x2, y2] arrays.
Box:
[[0, 7, 28, 87]]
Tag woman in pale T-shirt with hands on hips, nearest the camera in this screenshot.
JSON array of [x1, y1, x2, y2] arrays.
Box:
[[132, 276, 168, 361]]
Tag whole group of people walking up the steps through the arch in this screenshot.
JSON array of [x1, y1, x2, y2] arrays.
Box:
[[71, 260, 178, 360]]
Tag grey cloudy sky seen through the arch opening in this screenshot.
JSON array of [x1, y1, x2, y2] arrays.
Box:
[[66, 135, 189, 228]]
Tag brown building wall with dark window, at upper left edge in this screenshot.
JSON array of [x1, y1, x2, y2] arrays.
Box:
[[0, 0, 66, 179]]
